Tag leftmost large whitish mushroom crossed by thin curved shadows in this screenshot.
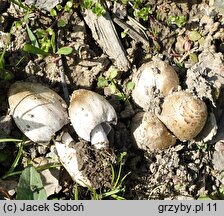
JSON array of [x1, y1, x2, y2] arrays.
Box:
[[8, 82, 69, 143]]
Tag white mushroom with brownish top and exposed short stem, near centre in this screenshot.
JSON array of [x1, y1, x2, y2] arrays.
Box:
[[69, 89, 117, 148]]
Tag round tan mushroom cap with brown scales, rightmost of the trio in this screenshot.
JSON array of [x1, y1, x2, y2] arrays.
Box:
[[158, 91, 207, 141]]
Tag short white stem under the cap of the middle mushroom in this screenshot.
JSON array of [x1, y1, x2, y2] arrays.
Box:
[[90, 124, 109, 149]]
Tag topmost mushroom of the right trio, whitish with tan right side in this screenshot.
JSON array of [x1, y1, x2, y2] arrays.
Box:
[[132, 58, 179, 110]]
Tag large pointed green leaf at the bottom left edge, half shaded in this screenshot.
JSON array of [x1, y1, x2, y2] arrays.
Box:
[[16, 166, 47, 200]]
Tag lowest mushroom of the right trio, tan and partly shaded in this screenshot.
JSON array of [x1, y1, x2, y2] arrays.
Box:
[[131, 112, 176, 150]]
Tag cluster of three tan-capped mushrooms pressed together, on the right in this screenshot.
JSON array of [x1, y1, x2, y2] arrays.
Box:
[[131, 59, 207, 150]]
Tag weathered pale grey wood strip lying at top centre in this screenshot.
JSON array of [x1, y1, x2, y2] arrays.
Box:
[[83, 0, 130, 71]]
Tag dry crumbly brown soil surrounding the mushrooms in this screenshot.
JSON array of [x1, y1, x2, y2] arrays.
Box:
[[0, 0, 224, 199]]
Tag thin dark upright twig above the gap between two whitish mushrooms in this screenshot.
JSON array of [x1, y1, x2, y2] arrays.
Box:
[[56, 30, 69, 104]]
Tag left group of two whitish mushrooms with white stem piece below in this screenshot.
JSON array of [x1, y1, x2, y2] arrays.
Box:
[[8, 82, 117, 186]]
